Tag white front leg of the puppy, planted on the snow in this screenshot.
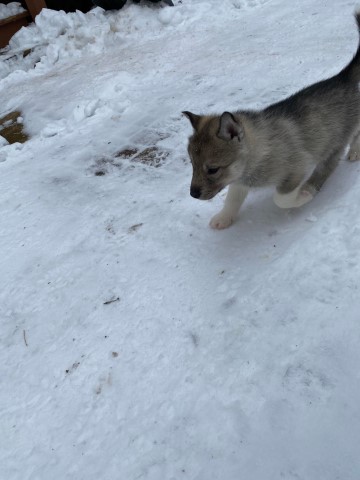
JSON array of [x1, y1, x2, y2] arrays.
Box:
[[210, 183, 249, 230]]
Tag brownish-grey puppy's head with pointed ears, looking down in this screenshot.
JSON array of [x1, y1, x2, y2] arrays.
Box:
[[183, 112, 244, 200]]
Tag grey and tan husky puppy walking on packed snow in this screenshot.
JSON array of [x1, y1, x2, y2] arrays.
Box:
[[183, 10, 360, 229]]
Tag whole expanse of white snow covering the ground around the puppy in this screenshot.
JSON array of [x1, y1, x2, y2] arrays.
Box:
[[0, 0, 360, 480]]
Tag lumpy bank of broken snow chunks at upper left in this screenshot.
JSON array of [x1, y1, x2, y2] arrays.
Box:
[[0, 4, 186, 79]]
